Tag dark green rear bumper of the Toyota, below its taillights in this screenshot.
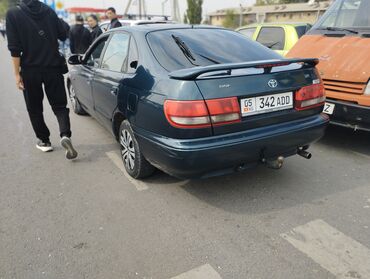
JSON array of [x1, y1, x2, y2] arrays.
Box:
[[134, 114, 329, 178]]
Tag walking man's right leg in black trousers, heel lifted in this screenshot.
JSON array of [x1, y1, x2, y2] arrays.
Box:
[[43, 73, 77, 159]]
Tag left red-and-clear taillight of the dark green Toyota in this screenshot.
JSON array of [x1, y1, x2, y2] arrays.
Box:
[[164, 97, 241, 128]]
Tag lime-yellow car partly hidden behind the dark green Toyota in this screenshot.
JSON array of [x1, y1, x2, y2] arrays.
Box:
[[237, 23, 311, 56]]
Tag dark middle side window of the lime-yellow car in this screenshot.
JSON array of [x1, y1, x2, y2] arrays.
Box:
[[257, 27, 285, 50]]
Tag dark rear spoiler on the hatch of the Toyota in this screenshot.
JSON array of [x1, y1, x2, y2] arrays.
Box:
[[169, 58, 319, 80]]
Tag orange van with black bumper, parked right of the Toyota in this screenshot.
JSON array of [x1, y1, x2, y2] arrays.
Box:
[[287, 0, 370, 131]]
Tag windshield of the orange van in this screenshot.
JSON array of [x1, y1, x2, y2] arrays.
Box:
[[314, 0, 370, 29]]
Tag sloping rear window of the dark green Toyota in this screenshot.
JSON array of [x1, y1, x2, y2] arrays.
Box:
[[147, 28, 281, 71]]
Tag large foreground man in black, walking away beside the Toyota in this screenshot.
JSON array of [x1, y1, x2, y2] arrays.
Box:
[[6, 0, 77, 159]]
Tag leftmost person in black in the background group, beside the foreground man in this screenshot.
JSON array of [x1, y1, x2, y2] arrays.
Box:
[[69, 15, 91, 54]]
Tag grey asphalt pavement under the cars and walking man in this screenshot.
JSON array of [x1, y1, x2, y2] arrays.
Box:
[[0, 39, 370, 279]]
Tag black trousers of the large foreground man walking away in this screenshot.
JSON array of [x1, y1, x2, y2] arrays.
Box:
[[22, 71, 72, 142]]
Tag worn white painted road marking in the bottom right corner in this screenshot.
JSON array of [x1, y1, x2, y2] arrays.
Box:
[[281, 220, 370, 279]]
